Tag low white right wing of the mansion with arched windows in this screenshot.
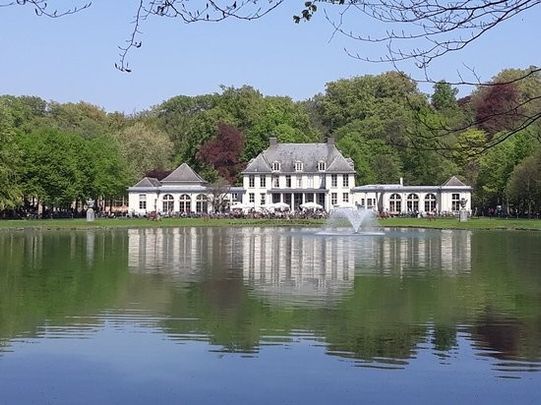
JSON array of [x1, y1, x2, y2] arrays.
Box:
[[353, 176, 472, 215]]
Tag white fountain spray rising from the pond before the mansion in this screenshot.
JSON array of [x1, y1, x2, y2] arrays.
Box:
[[323, 206, 384, 235]]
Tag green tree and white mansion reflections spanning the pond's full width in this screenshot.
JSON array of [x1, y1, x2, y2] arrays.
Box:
[[0, 228, 541, 366]]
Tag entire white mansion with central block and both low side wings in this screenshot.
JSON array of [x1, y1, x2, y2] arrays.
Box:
[[128, 138, 471, 215]]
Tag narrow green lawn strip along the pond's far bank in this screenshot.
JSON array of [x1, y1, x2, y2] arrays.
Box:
[[0, 218, 541, 230]]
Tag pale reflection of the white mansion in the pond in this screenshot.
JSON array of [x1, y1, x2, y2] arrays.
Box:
[[128, 228, 471, 300]]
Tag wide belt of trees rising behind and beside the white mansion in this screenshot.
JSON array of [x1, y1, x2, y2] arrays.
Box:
[[0, 68, 541, 210]]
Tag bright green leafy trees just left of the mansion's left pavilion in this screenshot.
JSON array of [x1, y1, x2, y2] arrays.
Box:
[[19, 128, 127, 208]]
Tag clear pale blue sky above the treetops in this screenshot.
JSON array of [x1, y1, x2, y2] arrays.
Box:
[[0, 0, 541, 113]]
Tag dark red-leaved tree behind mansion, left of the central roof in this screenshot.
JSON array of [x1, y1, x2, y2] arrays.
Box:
[[199, 123, 244, 184]]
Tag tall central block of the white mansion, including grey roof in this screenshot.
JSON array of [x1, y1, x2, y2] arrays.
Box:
[[242, 138, 355, 211]]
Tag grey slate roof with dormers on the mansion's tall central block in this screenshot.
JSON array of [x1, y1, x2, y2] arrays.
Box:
[[243, 143, 355, 173]]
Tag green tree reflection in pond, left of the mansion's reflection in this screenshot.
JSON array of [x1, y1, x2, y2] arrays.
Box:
[[0, 231, 127, 348]]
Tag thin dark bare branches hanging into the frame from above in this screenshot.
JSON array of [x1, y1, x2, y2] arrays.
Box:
[[7, 0, 541, 149]]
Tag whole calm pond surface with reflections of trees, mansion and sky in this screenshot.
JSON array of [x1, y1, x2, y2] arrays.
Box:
[[0, 228, 541, 404]]
